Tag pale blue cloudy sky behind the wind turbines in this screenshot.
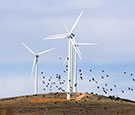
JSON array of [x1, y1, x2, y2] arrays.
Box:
[[0, 0, 135, 100]]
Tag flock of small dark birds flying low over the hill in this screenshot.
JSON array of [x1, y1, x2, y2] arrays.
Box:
[[41, 61, 135, 100]]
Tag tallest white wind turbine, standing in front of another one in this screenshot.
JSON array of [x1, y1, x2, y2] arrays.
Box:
[[43, 11, 83, 100]]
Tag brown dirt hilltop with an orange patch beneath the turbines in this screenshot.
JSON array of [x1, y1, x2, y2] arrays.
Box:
[[0, 93, 135, 115]]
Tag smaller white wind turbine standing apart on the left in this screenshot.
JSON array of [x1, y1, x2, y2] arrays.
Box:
[[22, 42, 56, 94]]
